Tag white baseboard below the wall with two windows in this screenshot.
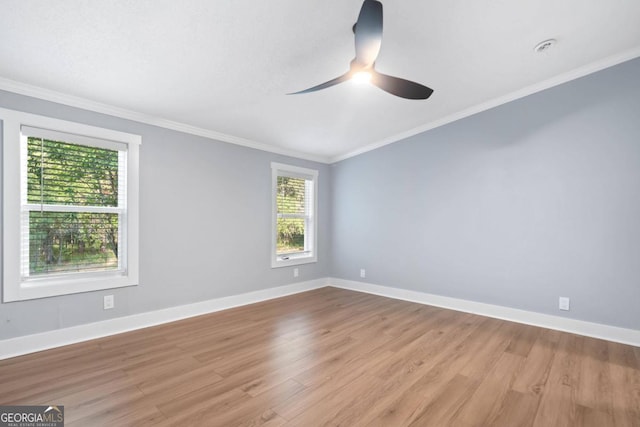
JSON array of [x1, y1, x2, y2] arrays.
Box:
[[0, 278, 327, 360]]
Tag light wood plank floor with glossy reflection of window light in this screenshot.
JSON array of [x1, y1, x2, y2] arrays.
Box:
[[0, 288, 640, 427]]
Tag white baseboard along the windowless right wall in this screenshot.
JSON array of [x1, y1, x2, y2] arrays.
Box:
[[328, 278, 640, 347]]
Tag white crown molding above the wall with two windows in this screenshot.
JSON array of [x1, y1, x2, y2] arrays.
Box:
[[0, 77, 329, 163]]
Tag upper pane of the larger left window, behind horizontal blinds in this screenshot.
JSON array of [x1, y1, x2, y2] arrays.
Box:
[[27, 137, 118, 206]]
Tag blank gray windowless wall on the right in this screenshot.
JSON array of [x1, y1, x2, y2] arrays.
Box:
[[331, 59, 640, 329]]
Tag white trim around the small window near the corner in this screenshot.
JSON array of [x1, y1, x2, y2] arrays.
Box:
[[271, 162, 318, 268]]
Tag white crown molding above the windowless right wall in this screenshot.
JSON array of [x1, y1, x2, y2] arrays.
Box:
[[329, 47, 640, 163]]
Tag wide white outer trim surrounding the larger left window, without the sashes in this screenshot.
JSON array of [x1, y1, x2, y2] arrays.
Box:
[[0, 108, 142, 302]]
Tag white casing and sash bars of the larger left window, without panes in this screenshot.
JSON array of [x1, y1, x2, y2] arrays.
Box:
[[0, 108, 142, 303]]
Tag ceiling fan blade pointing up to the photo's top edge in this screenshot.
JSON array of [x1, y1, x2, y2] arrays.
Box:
[[353, 0, 382, 67]]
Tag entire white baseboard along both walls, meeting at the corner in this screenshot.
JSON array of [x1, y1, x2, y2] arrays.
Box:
[[0, 278, 640, 360]]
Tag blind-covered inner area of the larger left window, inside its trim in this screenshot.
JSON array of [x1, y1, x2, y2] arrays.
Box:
[[21, 126, 127, 278]]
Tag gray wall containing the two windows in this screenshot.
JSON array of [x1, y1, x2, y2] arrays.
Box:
[[0, 91, 330, 339]]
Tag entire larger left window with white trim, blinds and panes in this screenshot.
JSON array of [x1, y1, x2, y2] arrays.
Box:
[[0, 109, 141, 302]]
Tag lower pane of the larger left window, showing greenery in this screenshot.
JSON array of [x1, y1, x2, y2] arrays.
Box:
[[29, 212, 118, 275]]
